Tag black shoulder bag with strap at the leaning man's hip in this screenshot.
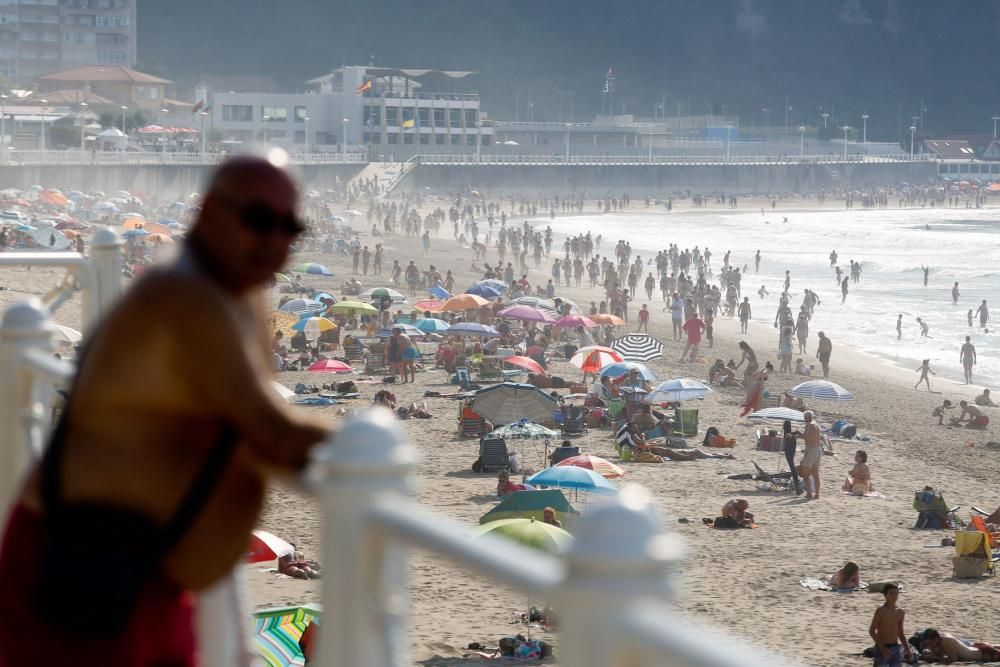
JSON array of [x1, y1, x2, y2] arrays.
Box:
[[36, 386, 236, 639]]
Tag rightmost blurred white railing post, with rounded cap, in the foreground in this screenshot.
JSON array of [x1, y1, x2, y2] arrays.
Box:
[[554, 485, 682, 667]]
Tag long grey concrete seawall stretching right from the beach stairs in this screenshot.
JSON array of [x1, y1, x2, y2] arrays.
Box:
[[397, 162, 937, 195]]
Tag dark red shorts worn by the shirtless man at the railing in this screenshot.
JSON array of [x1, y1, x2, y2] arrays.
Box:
[[0, 505, 197, 667]]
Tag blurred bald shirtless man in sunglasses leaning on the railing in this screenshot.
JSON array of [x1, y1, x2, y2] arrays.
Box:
[[0, 157, 327, 666]]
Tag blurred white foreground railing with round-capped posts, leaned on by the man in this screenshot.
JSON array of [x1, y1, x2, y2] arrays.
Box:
[[0, 235, 784, 667]]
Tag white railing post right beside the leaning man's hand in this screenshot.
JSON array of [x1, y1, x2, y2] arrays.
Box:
[[307, 408, 416, 667]]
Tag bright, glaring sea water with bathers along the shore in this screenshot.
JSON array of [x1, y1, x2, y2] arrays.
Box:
[[537, 208, 1000, 385]]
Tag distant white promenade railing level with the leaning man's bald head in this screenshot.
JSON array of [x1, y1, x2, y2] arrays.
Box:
[[0, 148, 368, 166]]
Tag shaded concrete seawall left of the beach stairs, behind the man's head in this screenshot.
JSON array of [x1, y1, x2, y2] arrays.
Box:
[[0, 163, 365, 198]]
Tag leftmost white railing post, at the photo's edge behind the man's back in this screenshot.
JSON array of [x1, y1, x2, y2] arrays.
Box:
[[0, 298, 55, 524]]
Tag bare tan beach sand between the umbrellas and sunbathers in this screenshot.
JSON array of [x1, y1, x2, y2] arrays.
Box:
[[0, 200, 1000, 667]]
